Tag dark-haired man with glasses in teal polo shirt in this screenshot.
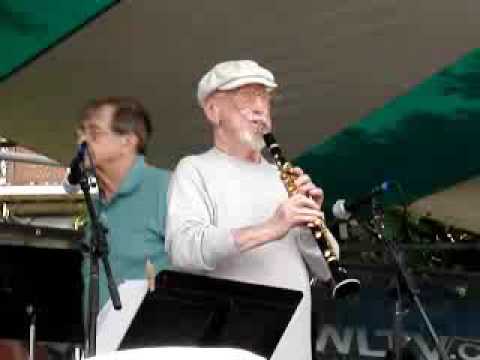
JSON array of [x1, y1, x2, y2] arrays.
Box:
[[78, 98, 169, 306]]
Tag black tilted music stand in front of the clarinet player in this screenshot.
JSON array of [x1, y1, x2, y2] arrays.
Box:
[[120, 271, 303, 358]]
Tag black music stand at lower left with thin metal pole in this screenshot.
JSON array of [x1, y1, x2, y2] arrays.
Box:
[[0, 241, 84, 358]]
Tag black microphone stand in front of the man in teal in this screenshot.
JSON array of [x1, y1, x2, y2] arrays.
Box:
[[79, 146, 122, 357]]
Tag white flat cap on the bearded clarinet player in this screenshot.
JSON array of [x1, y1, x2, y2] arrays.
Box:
[[197, 60, 278, 106]]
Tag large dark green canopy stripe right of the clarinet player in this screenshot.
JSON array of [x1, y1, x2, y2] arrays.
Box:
[[295, 49, 480, 210]]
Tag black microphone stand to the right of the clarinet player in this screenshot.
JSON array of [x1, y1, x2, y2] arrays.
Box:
[[368, 197, 449, 360]]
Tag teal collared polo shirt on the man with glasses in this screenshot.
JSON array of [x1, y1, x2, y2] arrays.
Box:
[[83, 156, 169, 308]]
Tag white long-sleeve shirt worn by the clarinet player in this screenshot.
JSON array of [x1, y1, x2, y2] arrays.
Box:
[[165, 148, 330, 360]]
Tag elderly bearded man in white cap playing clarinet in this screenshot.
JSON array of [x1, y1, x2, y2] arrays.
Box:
[[165, 60, 338, 360]]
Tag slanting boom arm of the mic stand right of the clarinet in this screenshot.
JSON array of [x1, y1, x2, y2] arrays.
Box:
[[366, 198, 449, 360]]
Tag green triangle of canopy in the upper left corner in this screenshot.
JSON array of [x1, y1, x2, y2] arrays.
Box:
[[0, 0, 117, 79]]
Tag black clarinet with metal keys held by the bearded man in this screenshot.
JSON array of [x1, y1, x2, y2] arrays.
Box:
[[263, 133, 360, 299]]
